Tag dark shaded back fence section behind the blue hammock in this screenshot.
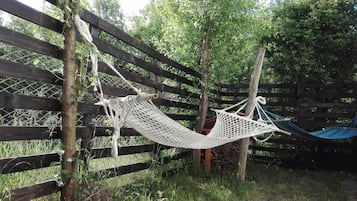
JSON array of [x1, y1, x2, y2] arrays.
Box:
[[216, 83, 357, 170]]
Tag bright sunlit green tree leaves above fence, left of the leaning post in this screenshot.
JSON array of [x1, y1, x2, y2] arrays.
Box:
[[133, 0, 261, 84]]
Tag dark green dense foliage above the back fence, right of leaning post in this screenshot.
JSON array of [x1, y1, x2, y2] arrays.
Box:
[[263, 0, 357, 83]]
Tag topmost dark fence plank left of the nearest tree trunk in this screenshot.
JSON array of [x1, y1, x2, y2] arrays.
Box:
[[0, 1, 63, 33]]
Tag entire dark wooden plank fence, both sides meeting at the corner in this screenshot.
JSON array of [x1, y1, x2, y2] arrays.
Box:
[[0, 0, 357, 200]]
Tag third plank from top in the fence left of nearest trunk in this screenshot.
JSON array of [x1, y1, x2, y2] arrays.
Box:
[[0, 59, 62, 85]]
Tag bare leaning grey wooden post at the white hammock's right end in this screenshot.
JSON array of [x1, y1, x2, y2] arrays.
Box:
[[237, 48, 265, 181]]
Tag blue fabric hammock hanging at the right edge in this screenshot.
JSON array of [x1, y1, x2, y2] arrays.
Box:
[[265, 111, 357, 140]]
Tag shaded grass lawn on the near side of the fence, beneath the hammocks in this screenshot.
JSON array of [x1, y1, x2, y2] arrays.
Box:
[[108, 164, 347, 201]]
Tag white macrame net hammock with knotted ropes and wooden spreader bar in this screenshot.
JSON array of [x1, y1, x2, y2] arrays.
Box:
[[75, 15, 279, 156]]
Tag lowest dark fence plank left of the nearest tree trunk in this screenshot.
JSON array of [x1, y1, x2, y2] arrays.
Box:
[[5, 180, 60, 201]]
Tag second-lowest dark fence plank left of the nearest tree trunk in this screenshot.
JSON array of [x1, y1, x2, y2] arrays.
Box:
[[0, 153, 60, 174]]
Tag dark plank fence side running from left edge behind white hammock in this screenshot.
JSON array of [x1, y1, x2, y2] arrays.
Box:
[[0, 0, 200, 200]]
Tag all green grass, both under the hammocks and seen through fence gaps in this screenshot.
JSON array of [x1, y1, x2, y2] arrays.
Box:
[[0, 138, 348, 201]]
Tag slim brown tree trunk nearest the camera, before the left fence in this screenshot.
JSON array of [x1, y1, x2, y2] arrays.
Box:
[[61, 0, 79, 201]]
